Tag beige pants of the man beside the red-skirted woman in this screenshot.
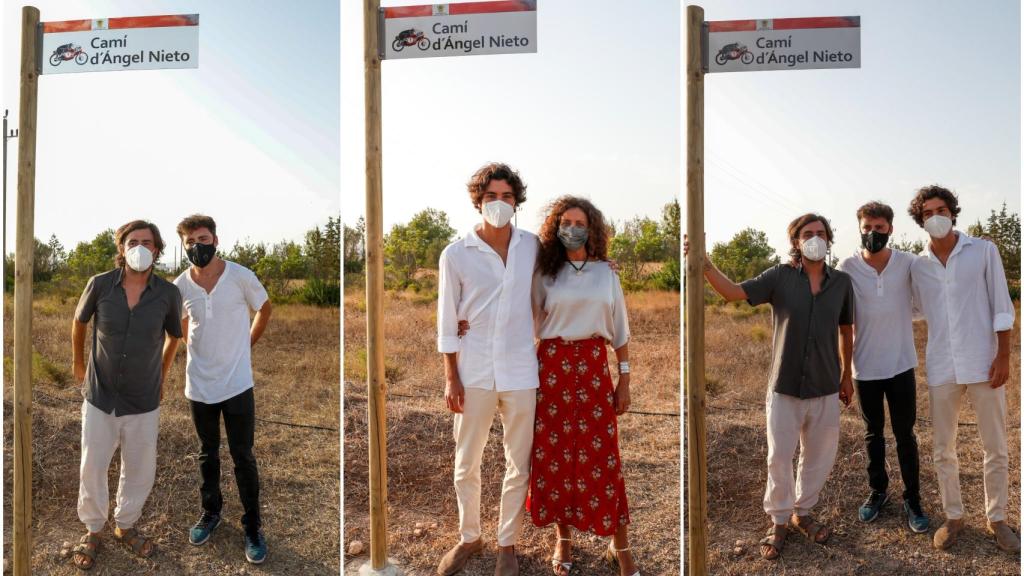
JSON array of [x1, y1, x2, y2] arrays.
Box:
[[455, 388, 537, 546]]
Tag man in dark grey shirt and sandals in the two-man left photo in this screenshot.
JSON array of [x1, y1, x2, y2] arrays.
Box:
[[72, 220, 181, 570]]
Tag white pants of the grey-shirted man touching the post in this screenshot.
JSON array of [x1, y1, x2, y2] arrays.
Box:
[[764, 389, 840, 524]]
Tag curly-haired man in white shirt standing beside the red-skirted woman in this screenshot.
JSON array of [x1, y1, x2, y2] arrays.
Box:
[[437, 163, 539, 576]]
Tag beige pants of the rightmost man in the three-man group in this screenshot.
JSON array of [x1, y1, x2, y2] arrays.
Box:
[[928, 382, 1010, 522]]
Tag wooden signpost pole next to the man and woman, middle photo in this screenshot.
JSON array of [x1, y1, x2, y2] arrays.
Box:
[[359, 0, 401, 575]]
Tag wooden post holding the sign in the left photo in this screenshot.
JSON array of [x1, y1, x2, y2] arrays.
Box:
[[13, 6, 40, 576]]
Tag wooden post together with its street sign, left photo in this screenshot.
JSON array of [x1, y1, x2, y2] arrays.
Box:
[[11, 11, 199, 576]]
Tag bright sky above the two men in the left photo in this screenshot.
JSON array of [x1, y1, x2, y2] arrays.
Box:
[[0, 0, 340, 262]]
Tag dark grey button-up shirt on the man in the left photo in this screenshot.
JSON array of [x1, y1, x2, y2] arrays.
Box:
[[75, 269, 181, 416]]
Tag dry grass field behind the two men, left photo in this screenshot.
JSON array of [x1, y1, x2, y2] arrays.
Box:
[[3, 297, 339, 576]]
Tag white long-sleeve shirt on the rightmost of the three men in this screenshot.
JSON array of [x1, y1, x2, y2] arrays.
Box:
[[910, 232, 1015, 386]]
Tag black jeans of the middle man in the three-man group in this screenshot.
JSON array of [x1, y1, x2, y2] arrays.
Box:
[[854, 368, 921, 502]]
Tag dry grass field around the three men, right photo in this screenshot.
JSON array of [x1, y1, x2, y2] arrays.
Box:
[[692, 306, 1021, 576]]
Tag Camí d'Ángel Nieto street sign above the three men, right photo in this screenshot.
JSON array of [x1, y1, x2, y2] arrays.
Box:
[[705, 16, 860, 72]]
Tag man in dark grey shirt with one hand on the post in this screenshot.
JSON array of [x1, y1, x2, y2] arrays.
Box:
[[686, 214, 854, 560]]
